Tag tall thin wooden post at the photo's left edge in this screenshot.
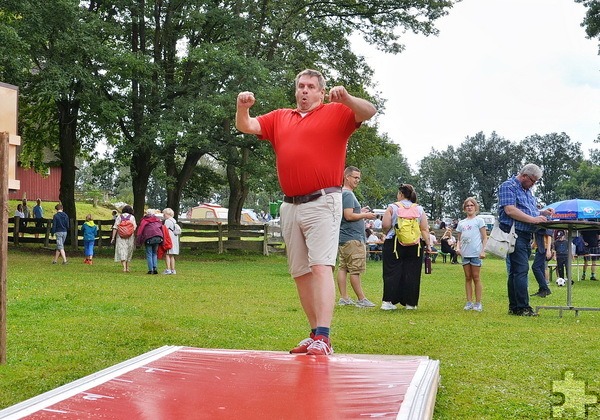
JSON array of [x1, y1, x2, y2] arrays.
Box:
[[0, 132, 9, 365]]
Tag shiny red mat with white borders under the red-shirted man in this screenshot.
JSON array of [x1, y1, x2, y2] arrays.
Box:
[[0, 347, 439, 420]]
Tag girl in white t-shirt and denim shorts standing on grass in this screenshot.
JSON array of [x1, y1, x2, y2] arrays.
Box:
[[456, 197, 487, 312]]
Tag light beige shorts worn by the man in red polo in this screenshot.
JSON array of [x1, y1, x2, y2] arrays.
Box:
[[279, 193, 342, 278]]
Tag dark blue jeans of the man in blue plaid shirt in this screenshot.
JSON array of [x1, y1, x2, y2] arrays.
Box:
[[506, 231, 531, 312]]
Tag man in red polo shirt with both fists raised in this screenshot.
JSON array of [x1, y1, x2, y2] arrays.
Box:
[[236, 70, 377, 355]]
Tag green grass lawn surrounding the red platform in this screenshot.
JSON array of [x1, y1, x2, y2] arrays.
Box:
[[0, 249, 600, 419]]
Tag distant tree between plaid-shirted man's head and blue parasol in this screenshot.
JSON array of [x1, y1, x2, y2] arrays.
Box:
[[521, 133, 583, 204]]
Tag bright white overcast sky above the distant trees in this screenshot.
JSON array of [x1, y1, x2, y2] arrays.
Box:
[[359, 0, 600, 168]]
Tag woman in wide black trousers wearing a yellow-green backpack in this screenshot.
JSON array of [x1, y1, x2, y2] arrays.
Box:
[[381, 184, 431, 311]]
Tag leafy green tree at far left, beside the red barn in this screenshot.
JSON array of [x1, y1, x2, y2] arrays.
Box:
[[0, 0, 108, 218]]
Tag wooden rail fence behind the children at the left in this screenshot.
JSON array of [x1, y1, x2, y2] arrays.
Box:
[[8, 216, 284, 255]]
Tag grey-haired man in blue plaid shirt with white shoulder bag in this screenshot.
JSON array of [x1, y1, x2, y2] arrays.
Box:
[[498, 163, 554, 316]]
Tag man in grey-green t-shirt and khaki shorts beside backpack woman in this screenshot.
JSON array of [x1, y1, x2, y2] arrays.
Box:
[[337, 166, 375, 308]]
